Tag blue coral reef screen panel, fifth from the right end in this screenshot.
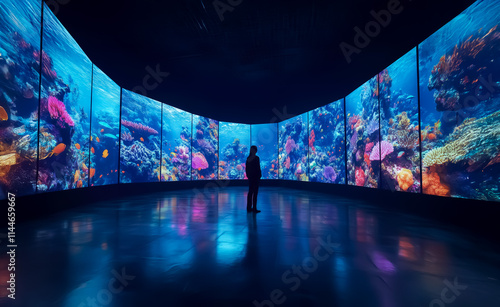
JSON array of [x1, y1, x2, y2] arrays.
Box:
[[279, 113, 309, 181]]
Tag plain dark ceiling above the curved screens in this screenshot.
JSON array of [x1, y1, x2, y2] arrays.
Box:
[[46, 0, 474, 123]]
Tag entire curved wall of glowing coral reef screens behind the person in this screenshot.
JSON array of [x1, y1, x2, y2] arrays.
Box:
[[0, 0, 500, 201]]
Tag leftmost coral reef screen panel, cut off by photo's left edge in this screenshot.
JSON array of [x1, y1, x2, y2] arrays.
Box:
[[0, 0, 41, 199]]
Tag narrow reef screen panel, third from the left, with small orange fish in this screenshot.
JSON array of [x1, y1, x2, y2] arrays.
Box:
[[89, 66, 121, 186]]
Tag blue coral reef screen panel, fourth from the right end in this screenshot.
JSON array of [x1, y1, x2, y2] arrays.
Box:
[[308, 99, 346, 184]]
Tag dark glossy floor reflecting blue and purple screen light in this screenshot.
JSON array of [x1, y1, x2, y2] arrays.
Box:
[[0, 187, 500, 307]]
